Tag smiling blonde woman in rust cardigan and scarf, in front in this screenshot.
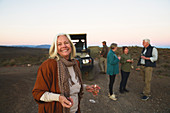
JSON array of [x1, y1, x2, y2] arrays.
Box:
[[32, 34, 100, 113]]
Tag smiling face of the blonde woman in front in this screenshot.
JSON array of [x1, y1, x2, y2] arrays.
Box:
[[57, 35, 72, 60]]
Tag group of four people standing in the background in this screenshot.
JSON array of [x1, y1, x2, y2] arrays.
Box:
[[99, 39, 158, 100]]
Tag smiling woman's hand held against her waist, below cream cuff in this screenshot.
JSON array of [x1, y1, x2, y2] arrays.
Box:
[[59, 96, 73, 108]]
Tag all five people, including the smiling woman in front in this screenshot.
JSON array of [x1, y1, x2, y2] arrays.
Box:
[[32, 34, 157, 113]]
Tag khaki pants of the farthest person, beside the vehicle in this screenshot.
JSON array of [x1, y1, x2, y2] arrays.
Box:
[[99, 57, 107, 73]]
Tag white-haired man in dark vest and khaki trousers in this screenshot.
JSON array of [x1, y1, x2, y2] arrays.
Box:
[[137, 39, 158, 100]]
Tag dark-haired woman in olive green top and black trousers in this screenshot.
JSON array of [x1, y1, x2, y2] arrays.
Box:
[[119, 46, 133, 93]]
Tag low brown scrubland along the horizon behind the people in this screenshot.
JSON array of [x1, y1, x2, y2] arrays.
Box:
[[0, 45, 170, 76]]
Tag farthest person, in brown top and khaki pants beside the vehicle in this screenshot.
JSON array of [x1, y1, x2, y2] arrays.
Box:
[[99, 41, 108, 74]]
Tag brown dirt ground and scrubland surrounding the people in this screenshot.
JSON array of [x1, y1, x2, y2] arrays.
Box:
[[0, 47, 170, 113]]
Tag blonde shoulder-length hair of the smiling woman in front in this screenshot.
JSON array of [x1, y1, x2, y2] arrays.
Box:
[[49, 33, 76, 60]]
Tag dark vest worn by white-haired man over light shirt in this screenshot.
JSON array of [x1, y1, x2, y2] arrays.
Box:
[[137, 45, 156, 67]]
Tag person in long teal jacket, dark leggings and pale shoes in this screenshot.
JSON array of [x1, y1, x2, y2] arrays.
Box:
[[107, 43, 120, 100]]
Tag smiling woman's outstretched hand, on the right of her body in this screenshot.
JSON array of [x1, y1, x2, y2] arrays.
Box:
[[86, 85, 101, 95]]
